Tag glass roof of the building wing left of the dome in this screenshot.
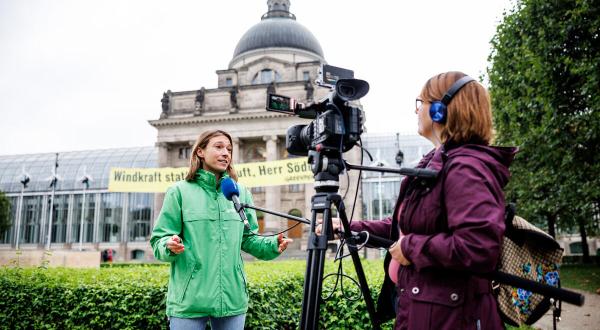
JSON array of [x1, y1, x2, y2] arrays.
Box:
[[0, 147, 158, 193]]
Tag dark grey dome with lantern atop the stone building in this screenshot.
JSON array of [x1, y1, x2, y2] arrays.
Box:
[[233, 0, 323, 59]]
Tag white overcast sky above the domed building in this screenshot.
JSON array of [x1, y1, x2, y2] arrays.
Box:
[[0, 0, 514, 155]]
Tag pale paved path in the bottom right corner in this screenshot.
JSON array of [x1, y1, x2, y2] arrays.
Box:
[[533, 290, 600, 330]]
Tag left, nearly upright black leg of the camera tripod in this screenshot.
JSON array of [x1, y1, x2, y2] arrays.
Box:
[[300, 194, 331, 330]]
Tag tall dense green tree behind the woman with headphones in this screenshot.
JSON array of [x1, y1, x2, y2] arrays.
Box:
[[488, 0, 600, 261]]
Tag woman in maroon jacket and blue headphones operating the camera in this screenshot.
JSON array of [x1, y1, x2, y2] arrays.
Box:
[[316, 72, 517, 329]]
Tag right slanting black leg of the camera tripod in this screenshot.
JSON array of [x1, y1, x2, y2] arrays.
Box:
[[335, 195, 381, 329]]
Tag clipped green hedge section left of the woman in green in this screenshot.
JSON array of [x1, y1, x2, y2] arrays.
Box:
[[0, 267, 168, 329]]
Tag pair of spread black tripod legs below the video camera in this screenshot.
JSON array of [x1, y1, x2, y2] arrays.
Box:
[[300, 192, 380, 330]]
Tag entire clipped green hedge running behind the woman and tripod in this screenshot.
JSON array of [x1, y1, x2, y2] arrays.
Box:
[[0, 260, 392, 329]]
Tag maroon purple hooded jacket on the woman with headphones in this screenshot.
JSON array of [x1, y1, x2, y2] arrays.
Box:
[[351, 144, 516, 330]]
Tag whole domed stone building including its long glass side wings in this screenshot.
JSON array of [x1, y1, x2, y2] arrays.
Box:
[[0, 0, 440, 267]]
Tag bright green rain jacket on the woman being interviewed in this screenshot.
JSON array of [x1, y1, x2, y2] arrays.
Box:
[[150, 170, 279, 318]]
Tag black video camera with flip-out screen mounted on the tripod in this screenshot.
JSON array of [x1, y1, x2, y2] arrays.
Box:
[[267, 64, 369, 156]]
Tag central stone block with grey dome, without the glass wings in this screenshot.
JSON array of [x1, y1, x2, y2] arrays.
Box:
[[150, 0, 361, 239]]
